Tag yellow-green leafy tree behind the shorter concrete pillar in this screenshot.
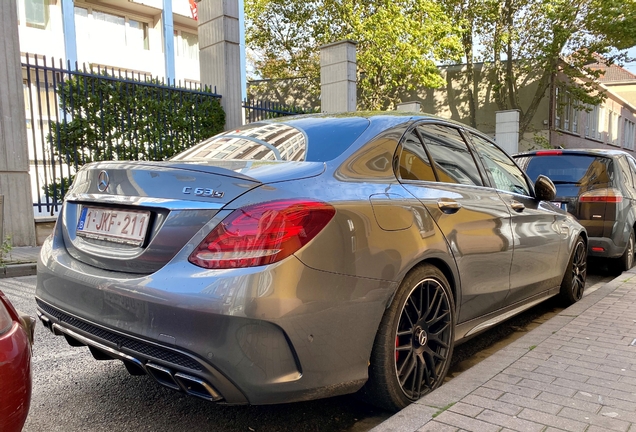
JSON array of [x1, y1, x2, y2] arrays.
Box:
[[245, 0, 461, 109]]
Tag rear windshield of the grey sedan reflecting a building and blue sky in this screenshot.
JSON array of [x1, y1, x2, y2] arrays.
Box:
[[172, 117, 369, 162]]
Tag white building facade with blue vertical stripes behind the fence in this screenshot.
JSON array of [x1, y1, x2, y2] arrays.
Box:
[[14, 0, 200, 84]]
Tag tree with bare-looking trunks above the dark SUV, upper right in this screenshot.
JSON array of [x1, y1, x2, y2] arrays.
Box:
[[480, 0, 636, 136]]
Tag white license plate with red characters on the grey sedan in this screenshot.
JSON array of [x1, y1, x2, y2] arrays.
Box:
[[77, 207, 150, 246]]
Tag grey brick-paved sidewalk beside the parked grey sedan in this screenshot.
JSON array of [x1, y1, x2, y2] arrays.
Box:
[[372, 268, 636, 432]]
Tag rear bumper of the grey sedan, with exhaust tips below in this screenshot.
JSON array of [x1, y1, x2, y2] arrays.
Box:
[[36, 233, 396, 404]]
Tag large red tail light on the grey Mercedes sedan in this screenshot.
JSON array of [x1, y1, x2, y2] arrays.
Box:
[[188, 200, 336, 269]]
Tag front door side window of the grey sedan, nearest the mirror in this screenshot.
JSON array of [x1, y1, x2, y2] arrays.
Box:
[[471, 134, 530, 196]]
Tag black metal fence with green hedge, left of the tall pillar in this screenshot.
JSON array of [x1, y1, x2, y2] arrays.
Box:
[[22, 54, 224, 216]]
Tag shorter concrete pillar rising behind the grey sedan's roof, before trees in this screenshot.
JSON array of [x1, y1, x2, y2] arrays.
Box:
[[320, 40, 357, 113]]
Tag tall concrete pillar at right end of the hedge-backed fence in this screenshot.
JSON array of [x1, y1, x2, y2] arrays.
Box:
[[199, 0, 243, 129]]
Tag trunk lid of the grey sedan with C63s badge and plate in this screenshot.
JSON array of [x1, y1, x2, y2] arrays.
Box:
[[60, 161, 324, 274]]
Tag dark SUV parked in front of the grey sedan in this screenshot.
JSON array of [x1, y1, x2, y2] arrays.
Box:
[[513, 149, 636, 272]]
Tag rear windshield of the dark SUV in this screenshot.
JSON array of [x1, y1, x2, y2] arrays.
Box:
[[515, 155, 613, 184]]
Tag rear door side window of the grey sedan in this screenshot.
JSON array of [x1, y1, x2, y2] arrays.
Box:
[[417, 124, 483, 186]]
